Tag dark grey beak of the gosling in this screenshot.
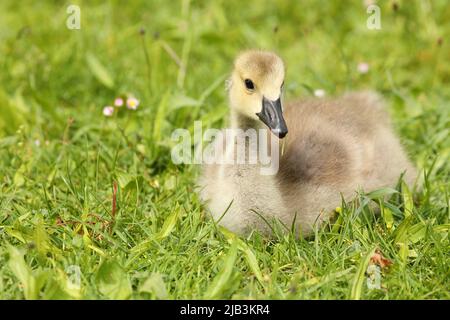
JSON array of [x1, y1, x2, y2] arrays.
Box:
[[256, 97, 288, 139]]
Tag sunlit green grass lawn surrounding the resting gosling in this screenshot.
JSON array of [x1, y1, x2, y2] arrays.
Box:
[[0, 0, 450, 299]]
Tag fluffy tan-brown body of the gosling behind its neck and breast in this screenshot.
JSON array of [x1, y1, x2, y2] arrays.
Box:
[[277, 92, 416, 222]]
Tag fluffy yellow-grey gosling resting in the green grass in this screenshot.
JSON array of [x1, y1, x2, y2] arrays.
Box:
[[198, 50, 416, 236]]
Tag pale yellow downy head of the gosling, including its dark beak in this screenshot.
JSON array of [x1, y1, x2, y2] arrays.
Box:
[[229, 50, 288, 138]]
